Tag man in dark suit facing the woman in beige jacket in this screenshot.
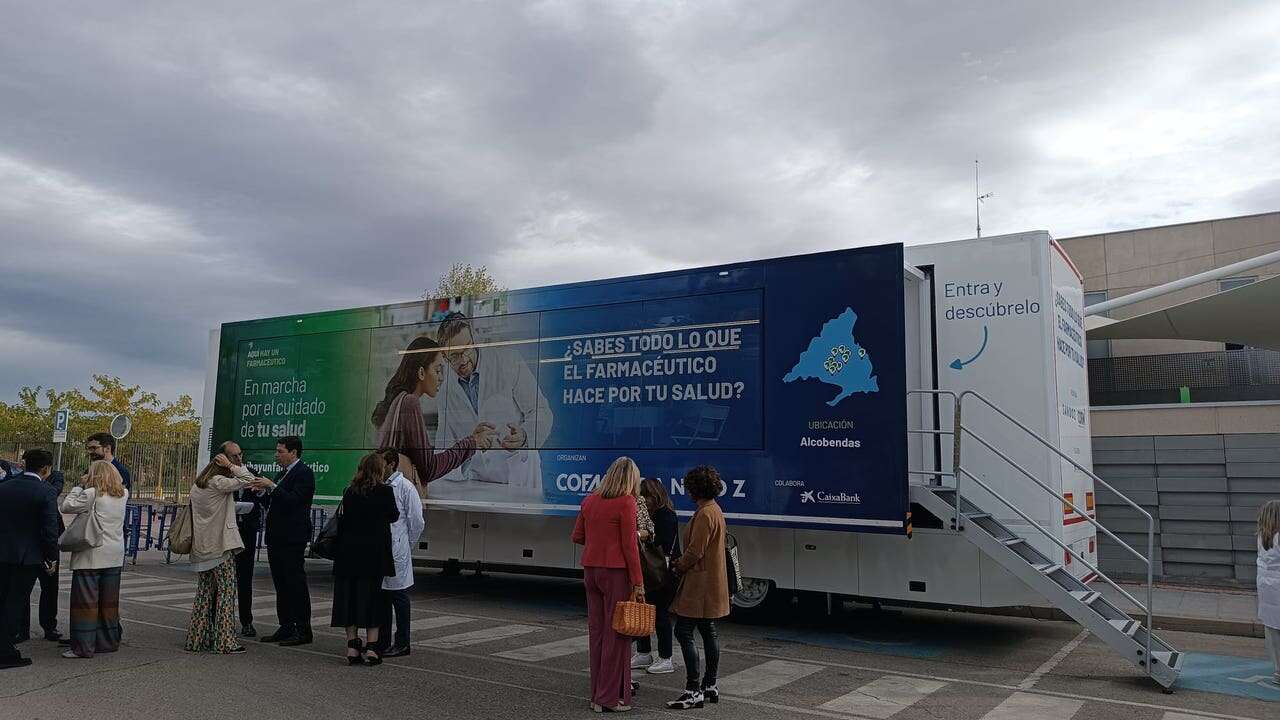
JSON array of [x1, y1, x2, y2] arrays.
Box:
[[251, 436, 316, 647]]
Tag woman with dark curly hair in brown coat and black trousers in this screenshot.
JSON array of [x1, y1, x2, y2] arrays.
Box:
[[667, 465, 728, 710]]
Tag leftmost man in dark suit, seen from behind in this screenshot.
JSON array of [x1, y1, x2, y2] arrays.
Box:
[[0, 450, 58, 669]]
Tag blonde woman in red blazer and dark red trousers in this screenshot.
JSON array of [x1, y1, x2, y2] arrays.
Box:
[[572, 457, 644, 712]]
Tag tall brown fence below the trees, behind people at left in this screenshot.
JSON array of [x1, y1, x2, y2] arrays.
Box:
[[0, 428, 200, 503]]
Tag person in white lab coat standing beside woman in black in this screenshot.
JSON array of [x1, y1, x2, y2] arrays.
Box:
[[378, 448, 426, 657]]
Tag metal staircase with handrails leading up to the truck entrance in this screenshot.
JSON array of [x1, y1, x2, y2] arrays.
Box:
[[908, 391, 1184, 689]]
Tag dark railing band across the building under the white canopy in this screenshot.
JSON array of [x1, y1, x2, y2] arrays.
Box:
[[1089, 348, 1280, 404]]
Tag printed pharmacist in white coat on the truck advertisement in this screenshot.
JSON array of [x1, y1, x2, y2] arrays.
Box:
[[430, 313, 553, 503]]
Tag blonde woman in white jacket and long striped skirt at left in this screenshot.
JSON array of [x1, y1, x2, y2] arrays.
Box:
[[61, 460, 129, 659]]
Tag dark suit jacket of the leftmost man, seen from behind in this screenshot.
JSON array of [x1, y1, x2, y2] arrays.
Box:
[[0, 475, 59, 568]]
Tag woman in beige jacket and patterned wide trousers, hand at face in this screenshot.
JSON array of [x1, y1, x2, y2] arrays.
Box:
[[186, 455, 253, 653]]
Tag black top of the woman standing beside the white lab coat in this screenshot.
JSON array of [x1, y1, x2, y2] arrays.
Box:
[[333, 486, 399, 578]]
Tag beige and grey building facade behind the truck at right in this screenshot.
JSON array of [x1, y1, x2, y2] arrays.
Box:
[[1060, 213, 1280, 585]]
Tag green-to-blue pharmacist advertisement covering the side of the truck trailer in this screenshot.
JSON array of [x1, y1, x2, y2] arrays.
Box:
[[212, 245, 909, 533]]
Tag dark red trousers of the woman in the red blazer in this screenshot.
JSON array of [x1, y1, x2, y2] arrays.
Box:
[[584, 568, 631, 707]]
